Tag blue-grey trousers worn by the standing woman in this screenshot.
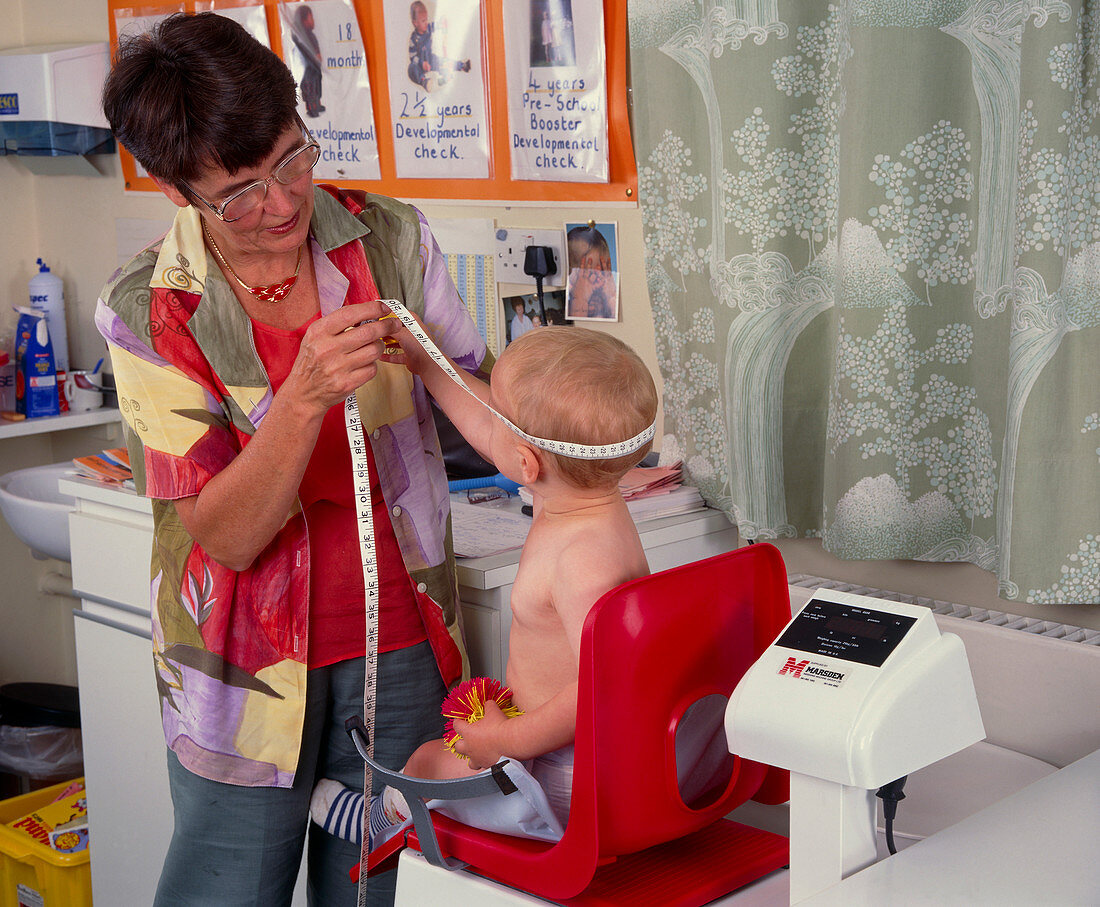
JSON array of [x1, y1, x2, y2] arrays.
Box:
[[154, 642, 446, 907]]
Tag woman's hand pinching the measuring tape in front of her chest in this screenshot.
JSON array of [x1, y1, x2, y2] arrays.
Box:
[[281, 300, 392, 416]]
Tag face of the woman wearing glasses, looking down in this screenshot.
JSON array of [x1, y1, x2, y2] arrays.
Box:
[[191, 123, 314, 254]]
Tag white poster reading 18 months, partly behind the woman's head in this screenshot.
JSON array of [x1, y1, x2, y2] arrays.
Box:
[[279, 0, 382, 180]]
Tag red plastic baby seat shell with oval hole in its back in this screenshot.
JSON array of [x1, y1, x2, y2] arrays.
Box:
[[420, 544, 791, 898]]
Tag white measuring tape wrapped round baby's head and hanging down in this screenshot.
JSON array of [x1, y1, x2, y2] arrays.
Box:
[[344, 299, 657, 907]]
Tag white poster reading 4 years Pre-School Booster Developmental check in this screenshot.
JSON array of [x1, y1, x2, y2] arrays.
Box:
[[504, 0, 607, 182]]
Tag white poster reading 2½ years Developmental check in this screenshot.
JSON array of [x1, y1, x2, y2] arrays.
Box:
[[384, 0, 488, 179]]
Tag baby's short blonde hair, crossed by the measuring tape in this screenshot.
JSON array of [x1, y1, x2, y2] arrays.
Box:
[[494, 327, 657, 488]]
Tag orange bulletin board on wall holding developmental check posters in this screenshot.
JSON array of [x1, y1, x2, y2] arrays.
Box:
[[108, 0, 638, 204]]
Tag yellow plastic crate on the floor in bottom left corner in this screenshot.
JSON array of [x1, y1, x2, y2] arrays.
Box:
[[0, 778, 91, 907]]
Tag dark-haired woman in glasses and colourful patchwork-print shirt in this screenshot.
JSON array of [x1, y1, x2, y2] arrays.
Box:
[[96, 13, 492, 907]]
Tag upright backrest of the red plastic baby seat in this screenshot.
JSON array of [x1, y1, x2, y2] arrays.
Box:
[[570, 544, 791, 856]]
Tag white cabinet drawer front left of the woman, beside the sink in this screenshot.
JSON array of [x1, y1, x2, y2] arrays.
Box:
[[69, 511, 153, 611]]
